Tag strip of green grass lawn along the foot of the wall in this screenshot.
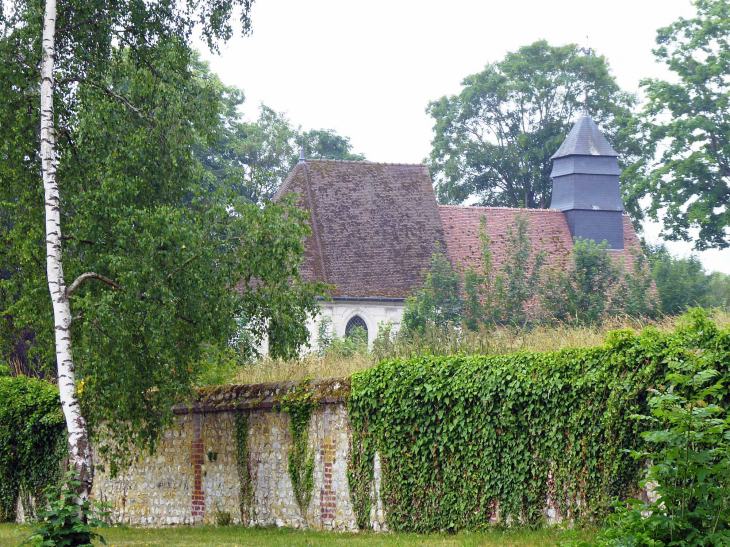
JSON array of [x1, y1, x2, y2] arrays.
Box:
[[0, 524, 592, 547]]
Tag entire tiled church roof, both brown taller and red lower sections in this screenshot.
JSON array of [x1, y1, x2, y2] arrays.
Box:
[[274, 160, 641, 298]]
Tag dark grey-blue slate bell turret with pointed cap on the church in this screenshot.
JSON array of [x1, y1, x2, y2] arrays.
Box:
[[550, 113, 624, 249]]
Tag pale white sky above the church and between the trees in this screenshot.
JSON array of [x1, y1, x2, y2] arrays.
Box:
[[200, 0, 730, 273]]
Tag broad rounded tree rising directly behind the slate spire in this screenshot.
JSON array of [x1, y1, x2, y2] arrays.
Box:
[[427, 41, 641, 209]]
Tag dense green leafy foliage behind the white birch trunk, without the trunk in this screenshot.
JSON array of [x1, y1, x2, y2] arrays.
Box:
[[0, 41, 321, 469]]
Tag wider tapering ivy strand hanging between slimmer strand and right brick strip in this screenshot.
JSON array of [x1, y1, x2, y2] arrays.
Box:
[[281, 379, 317, 515]]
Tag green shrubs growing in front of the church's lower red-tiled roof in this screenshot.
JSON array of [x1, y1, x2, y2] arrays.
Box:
[[403, 213, 656, 336]]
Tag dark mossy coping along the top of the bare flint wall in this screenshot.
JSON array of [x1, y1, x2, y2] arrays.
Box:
[[172, 378, 351, 414]]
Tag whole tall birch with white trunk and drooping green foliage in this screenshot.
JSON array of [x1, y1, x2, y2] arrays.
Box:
[[0, 0, 328, 498]]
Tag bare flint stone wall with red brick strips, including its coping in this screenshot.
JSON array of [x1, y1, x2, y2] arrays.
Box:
[[93, 379, 383, 531]]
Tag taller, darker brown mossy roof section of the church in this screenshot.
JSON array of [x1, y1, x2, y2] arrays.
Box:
[[274, 159, 444, 298]]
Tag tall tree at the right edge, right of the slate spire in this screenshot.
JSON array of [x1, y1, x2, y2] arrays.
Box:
[[632, 0, 730, 250]]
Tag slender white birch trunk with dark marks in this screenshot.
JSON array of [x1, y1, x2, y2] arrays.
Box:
[[41, 0, 93, 500]]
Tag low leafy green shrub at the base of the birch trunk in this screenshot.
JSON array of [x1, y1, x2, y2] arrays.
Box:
[[23, 471, 111, 547]]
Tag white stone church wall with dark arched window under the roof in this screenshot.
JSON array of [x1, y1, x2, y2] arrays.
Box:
[[307, 300, 405, 351]]
